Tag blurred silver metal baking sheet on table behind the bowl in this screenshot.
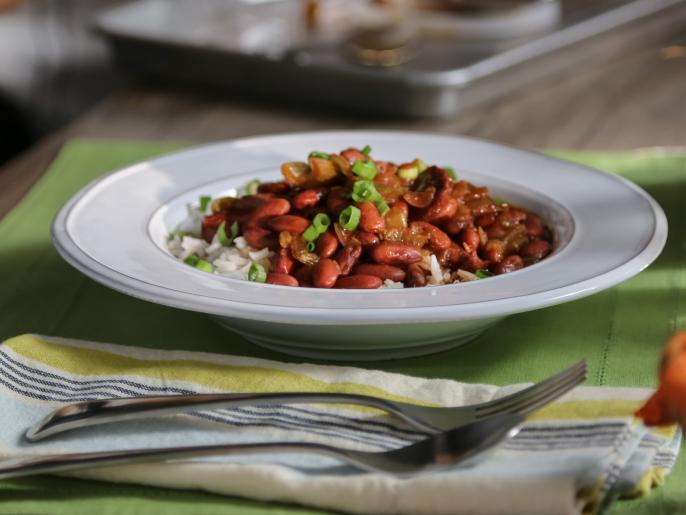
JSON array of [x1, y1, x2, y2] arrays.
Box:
[[96, 0, 686, 117]]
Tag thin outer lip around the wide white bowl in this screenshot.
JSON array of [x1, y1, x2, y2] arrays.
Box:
[[51, 130, 667, 325]]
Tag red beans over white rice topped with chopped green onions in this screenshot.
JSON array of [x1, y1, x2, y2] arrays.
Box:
[[168, 146, 553, 289]]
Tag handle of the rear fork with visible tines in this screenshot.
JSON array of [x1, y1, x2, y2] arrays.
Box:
[[26, 392, 436, 442]]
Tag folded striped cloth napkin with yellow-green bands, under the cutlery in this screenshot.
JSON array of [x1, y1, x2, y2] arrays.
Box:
[[0, 335, 681, 515]]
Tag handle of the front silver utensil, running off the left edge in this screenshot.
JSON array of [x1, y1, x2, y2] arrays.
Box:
[[0, 442, 379, 481]]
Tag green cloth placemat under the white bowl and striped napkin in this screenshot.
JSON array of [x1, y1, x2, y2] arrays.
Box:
[[0, 140, 686, 515]]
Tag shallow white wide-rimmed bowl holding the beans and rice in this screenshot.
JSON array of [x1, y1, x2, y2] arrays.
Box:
[[53, 131, 667, 360]]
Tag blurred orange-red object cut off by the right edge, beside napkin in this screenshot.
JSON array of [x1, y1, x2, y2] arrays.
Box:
[[636, 331, 686, 427]]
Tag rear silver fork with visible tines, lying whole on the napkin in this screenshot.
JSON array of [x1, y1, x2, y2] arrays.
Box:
[[26, 360, 586, 442]]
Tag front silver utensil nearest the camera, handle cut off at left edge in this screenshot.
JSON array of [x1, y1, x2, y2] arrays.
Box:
[[0, 414, 524, 481]]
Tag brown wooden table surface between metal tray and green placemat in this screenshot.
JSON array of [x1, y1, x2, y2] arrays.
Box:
[[0, 21, 686, 218]]
